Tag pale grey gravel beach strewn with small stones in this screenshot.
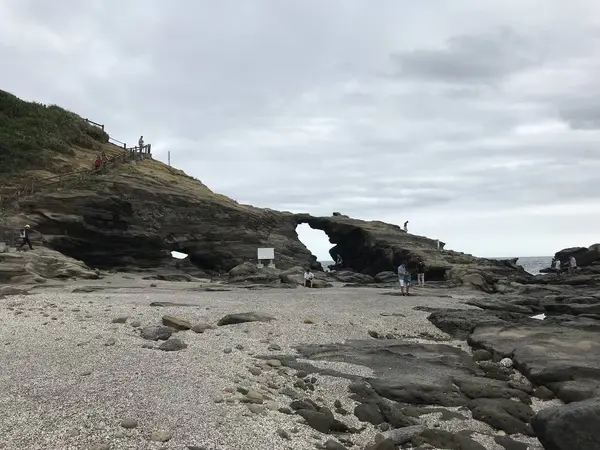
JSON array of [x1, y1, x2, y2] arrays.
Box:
[[0, 275, 541, 450]]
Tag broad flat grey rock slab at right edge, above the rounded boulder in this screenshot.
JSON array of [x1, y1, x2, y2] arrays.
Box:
[[469, 325, 600, 401]]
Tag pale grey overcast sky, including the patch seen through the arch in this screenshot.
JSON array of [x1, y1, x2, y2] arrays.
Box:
[[0, 0, 600, 258]]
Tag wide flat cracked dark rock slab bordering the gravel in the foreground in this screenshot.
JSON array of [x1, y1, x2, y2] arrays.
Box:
[[298, 340, 533, 435]]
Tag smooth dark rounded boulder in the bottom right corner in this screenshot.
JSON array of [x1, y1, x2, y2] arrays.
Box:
[[531, 397, 600, 450]]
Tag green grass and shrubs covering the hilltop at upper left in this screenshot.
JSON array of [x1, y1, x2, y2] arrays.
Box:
[[0, 90, 108, 181]]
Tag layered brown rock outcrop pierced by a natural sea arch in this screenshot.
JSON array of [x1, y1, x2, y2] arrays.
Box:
[[7, 151, 531, 286]]
